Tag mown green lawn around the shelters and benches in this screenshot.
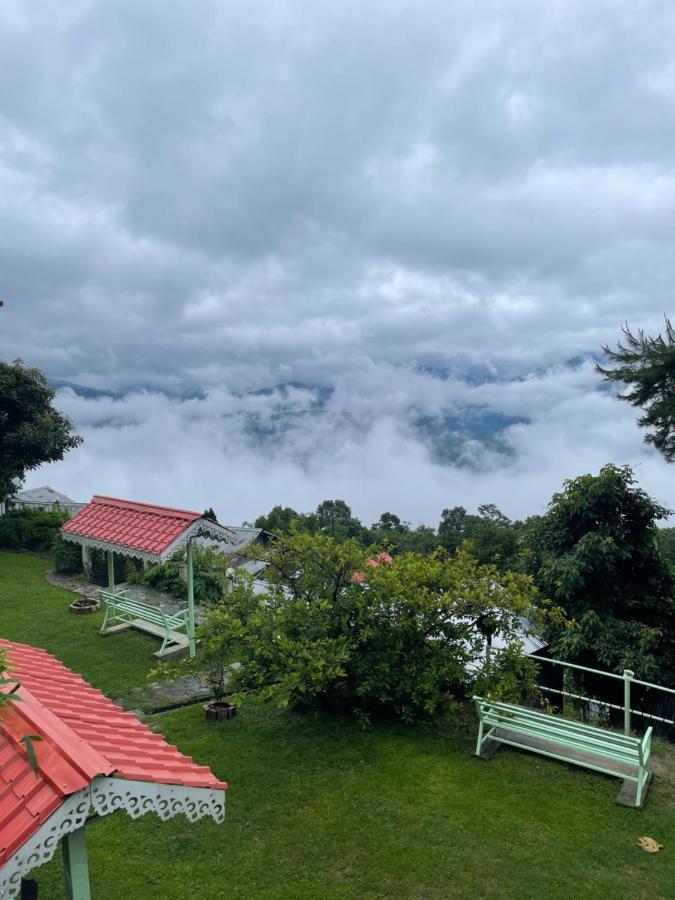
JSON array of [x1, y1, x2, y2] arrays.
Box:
[[0, 555, 675, 900]]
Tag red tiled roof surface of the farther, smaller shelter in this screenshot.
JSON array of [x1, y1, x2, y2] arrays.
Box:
[[61, 496, 203, 555]]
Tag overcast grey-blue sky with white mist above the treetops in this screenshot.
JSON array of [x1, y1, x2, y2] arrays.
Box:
[[0, 0, 675, 523]]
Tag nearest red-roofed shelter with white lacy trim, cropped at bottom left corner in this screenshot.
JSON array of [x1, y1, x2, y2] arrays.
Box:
[[0, 640, 227, 900]]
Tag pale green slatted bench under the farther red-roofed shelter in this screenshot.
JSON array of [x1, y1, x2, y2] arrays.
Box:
[[98, 590, 189, 657]]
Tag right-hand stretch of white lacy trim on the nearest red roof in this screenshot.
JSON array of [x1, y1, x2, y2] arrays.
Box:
[[91, 777, 225, 822]]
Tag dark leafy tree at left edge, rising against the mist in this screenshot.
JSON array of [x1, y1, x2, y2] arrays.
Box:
[[0, 360, 82, 500]]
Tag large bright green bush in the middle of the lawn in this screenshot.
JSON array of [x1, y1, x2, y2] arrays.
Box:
[[202, 532, 535, 721]]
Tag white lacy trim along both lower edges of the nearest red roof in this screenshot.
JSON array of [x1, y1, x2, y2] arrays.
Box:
[[0, 775, 226, 900]]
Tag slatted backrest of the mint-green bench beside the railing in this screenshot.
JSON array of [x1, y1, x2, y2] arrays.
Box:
[[474, 697, 651, 765]]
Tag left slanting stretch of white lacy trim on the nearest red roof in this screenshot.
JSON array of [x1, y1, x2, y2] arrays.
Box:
[[0, 786, 91, 900]]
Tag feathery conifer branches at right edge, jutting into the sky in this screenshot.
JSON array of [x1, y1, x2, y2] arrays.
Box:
[[596, 318, 675, 462]]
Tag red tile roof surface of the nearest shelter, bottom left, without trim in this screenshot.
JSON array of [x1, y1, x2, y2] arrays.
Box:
[[0, 640, 227, 866]]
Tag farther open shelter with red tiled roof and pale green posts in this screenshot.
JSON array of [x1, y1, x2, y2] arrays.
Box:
[[61, 496, 236, 657]]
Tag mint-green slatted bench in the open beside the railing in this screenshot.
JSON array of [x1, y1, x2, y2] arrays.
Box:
[[473, 697, 652, 807]]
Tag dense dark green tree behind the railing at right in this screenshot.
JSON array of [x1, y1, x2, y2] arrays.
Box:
[[521, 465, 675, 683]]
